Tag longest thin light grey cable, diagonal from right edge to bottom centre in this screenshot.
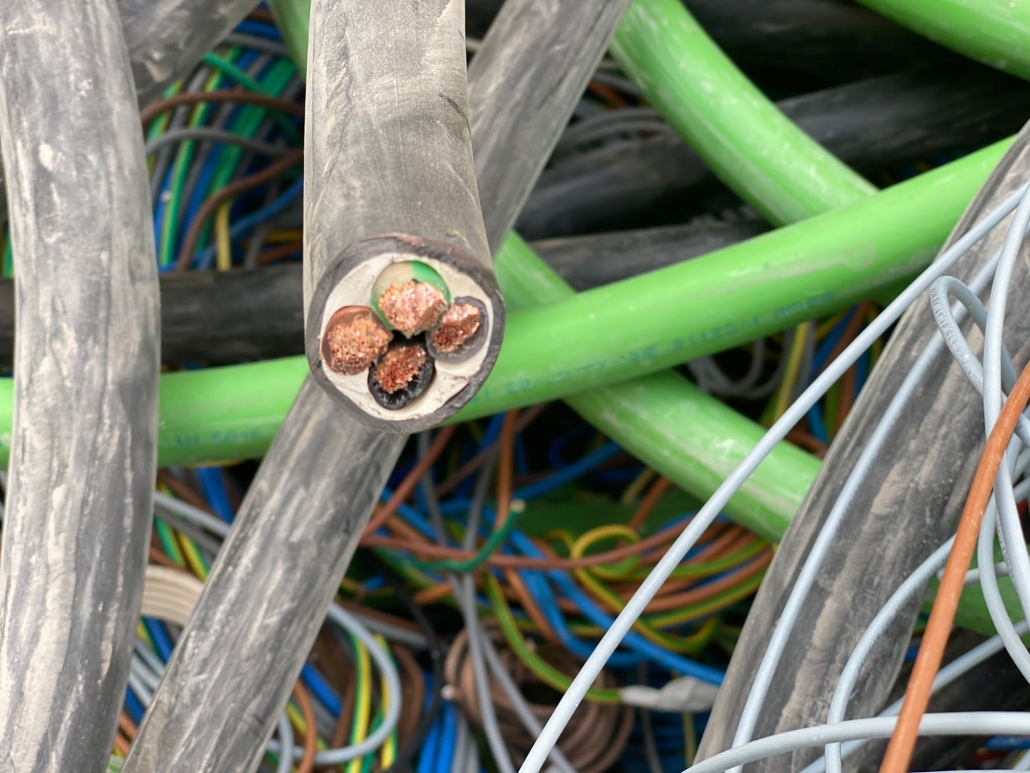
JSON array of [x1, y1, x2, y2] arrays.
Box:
[[520, 180, 1027, 773]]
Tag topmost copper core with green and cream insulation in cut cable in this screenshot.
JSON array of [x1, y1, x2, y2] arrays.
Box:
[[372, 261, 450, 338]]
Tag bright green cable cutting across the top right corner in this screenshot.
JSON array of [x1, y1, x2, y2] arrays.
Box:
[[858, 0, 1030, 79]]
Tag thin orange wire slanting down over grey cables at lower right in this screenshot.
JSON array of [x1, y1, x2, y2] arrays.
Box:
[[880, 363, 1030, 773]]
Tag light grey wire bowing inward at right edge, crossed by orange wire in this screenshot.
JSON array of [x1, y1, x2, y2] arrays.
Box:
[[984, 184, 1030, 630]]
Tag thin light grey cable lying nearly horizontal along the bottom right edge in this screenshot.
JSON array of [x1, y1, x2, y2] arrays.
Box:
[[685, 711, 1030, 773]]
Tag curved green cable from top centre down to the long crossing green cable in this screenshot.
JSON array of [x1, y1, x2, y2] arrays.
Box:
[[612, 0, 876, 226]]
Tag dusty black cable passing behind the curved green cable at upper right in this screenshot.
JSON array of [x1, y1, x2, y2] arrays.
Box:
[[516, 68, 1030, 239]]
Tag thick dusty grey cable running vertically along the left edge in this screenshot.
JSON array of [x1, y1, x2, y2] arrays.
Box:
[[0, 0, 160, 773]]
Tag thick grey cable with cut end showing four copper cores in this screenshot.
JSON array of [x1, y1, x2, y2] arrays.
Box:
[[304, 0, 504, 433]]
